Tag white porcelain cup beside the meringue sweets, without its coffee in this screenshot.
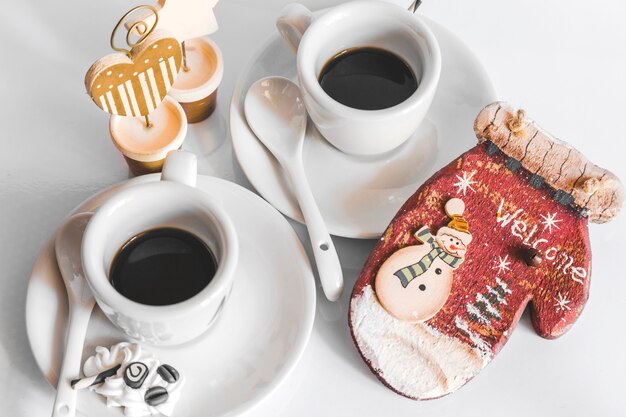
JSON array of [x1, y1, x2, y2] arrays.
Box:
[[81, 151, 239, 345]]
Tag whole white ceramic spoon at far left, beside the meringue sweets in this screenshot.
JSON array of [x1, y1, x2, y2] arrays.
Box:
[[52, 213, 95, 417]]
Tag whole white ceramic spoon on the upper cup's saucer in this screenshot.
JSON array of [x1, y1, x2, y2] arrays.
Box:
[[244, 77, 343, 301]]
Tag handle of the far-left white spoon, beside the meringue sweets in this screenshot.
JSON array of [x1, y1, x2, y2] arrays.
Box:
[[52, 303, 91, 417]]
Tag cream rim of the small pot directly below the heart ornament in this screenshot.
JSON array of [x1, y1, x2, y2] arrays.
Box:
[[109, 96, 187, 162]]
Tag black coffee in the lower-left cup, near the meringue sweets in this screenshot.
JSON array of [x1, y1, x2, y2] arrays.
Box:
[[109, 227, 217, 306]]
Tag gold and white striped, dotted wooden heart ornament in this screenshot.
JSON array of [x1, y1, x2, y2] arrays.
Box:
[[85, 30, 182, 116]]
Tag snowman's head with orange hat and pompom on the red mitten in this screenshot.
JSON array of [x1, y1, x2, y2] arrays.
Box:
[[435, 198, 472, 257]]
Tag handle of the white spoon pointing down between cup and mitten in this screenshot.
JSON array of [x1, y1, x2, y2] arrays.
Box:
[[286, 164, 343, 301]]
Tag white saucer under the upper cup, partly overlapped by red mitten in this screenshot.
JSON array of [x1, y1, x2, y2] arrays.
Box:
[[230, 19, 496, 238]]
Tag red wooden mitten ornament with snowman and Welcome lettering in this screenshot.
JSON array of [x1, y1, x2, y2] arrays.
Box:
[[349, 103, 624, 399]]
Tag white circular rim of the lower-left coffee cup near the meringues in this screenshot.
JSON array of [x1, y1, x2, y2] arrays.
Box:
[[81, 181, 239, 321]]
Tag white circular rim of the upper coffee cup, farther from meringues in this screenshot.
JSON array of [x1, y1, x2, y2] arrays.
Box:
[[296, 0, 441, 120]]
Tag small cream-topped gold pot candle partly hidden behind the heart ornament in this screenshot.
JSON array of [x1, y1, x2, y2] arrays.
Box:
[[169, 38, 224, 123]]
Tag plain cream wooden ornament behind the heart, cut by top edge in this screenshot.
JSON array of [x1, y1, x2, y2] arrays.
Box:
[[125, 0, 218, 42]]
